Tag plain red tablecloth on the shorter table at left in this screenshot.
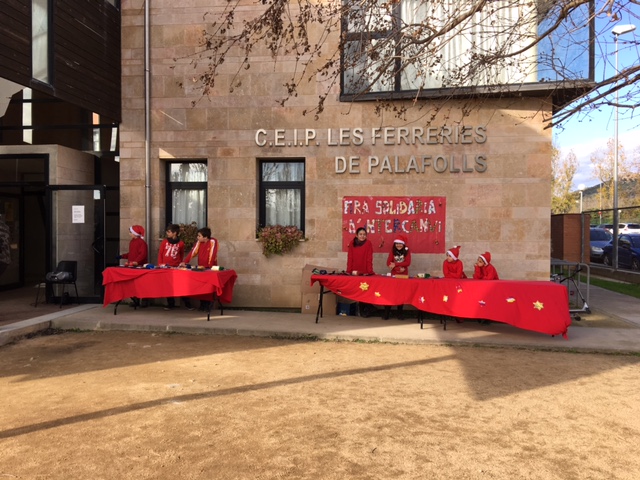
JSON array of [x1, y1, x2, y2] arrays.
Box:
[[102, 267, 238, 307]]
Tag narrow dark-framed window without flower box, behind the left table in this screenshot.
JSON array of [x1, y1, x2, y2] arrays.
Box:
[[167, 162, 208, 227]]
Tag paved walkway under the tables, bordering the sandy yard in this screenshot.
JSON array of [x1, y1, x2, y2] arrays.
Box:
[[0, 286, 640, 353]]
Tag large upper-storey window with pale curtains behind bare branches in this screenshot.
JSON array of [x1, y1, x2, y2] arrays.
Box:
[[342, 0, 592, 96]]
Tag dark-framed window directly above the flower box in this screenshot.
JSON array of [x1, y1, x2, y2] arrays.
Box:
[[258, 160, 305, 230]]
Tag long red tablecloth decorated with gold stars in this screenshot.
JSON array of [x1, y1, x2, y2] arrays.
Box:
[[311, 275, 571, 338]]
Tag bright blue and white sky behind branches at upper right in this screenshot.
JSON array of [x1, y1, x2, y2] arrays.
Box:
[[553, 5, 640, 189]]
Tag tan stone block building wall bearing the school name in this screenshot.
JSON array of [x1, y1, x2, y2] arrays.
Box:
[[120, 0, 551, 308]]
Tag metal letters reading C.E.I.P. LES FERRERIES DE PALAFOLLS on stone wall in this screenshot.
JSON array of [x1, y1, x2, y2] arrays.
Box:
[[254, 125, 488, 175]]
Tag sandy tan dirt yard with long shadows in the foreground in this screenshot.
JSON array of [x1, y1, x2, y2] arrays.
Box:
[[0, 332, 640, 480]]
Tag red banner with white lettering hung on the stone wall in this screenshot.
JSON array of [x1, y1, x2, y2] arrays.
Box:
[[342, 197, 447, 253]]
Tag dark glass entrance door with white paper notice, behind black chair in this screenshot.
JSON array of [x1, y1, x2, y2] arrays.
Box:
[[47, 185, 105, 303]]
